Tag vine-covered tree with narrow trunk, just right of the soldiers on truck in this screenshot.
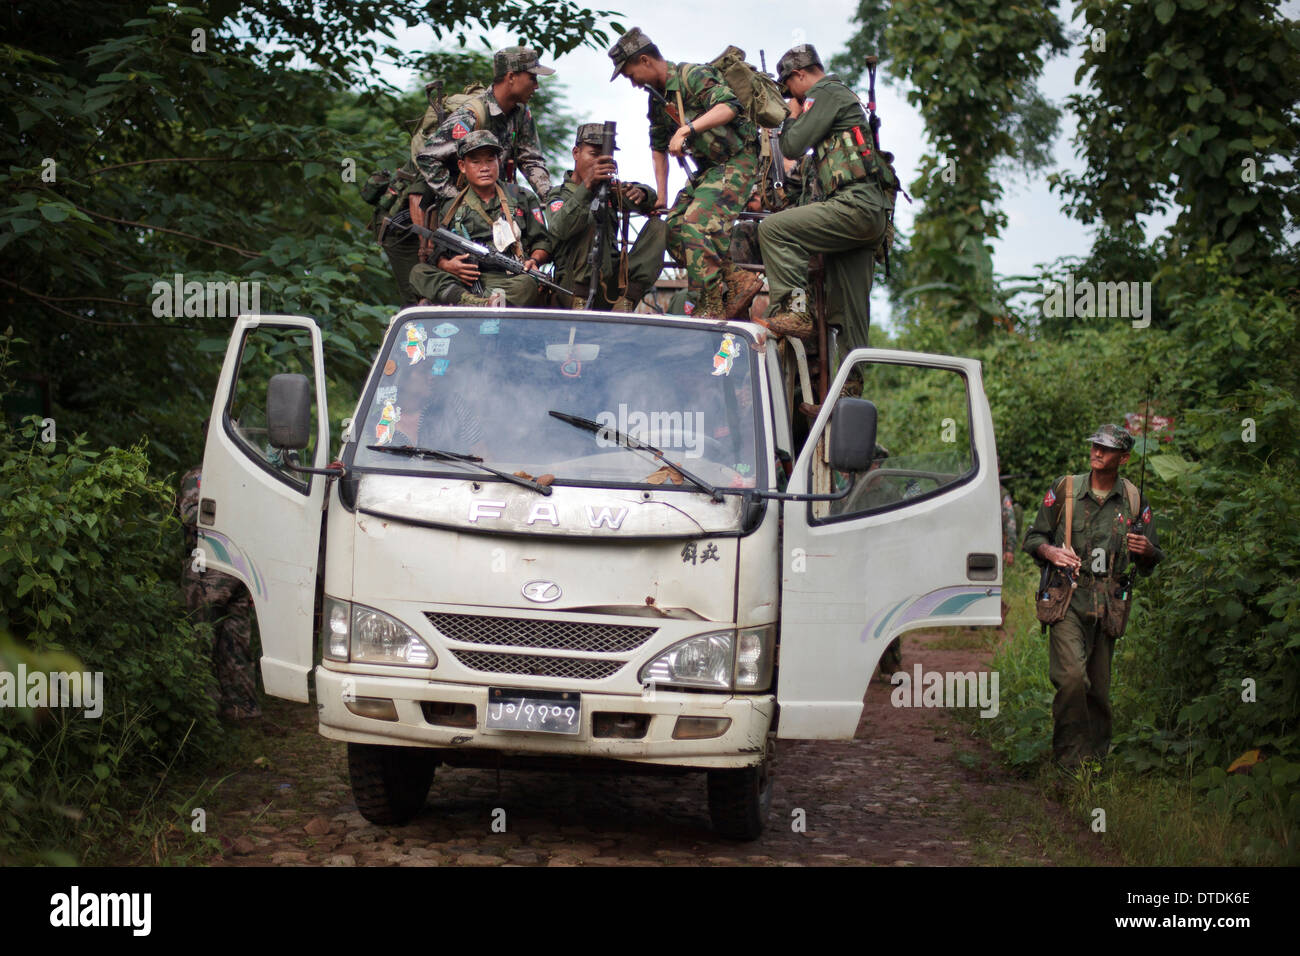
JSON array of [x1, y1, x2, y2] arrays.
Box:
[[831, 0, 1066, 337]]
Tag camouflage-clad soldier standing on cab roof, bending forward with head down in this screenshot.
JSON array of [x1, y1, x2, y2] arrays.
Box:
[[610, 27, 763, 319]]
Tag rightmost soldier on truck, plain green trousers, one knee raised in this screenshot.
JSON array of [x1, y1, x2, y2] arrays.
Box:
[[758, 44, 891, 347]]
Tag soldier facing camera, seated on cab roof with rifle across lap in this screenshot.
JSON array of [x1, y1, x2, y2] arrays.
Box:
[[411, 130, 551, 306]]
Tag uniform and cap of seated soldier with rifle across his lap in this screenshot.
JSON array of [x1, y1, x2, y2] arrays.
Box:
[[411, 130, 553, 306]]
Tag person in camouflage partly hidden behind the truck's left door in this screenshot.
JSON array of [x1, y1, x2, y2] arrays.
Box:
[[177, 468, 261, 721]]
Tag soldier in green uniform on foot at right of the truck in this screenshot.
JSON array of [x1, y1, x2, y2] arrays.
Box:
[[1024, 425, 1165, 767]]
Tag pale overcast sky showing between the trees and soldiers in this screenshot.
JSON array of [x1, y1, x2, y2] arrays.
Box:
[[374, 0, 1300, 329]]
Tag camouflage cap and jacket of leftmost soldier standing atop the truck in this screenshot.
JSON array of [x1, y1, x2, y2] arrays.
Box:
[[416, 47, 555, 202]]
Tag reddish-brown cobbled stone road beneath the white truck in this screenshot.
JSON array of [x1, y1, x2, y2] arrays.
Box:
[[208, 635, 1092, 866]]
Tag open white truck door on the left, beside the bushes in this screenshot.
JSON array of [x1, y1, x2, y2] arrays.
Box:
[[199, 316, 329, 701]]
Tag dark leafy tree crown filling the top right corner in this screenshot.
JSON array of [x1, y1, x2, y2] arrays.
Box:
[[1053, 0, 1300, 273]]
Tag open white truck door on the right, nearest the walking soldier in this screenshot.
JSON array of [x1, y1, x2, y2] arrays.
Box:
[[777, 349, 1002, 739]]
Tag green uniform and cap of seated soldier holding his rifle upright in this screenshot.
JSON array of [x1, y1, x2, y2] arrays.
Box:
[[546, 122, 668, 311]]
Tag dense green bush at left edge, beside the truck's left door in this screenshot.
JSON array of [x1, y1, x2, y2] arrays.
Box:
[[0, 400, 216, 862]]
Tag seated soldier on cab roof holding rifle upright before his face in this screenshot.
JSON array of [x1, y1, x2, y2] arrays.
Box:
[[547, 122, 668, 312]]
